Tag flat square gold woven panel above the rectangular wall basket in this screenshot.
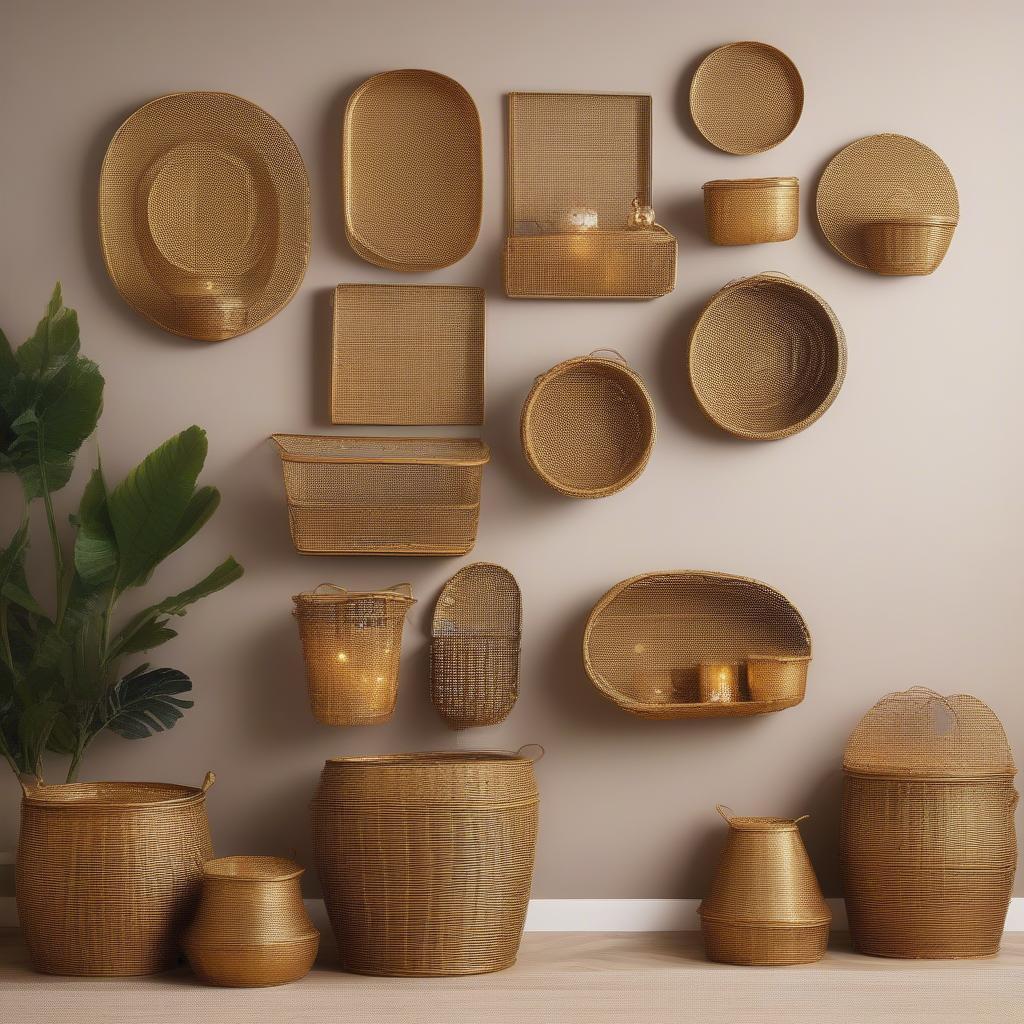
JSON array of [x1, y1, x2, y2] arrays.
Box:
[[331, 285, 483, 425]]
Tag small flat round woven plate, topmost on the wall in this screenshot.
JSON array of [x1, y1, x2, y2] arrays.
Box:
[[690, 42, 804, 157]]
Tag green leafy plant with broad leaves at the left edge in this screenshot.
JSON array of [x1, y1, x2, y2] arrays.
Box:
[[0, 284, 242, 780]]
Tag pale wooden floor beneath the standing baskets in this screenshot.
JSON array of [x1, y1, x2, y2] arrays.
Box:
[[0, 930, 1024, 1024]]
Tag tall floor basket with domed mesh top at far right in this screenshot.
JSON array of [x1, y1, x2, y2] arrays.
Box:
[[840, 687, 1017, 958]]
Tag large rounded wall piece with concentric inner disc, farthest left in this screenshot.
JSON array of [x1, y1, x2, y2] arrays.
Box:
[[99, 92, 309, 341]]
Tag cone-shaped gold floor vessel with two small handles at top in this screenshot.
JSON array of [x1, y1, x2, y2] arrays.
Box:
[[698, 804, 831, 967]]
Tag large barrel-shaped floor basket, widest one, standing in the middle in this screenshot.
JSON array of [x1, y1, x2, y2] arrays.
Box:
[[312, 752, 538, 977]]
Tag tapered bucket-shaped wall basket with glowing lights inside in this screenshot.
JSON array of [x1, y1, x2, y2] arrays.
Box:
[[292, 584, 416, 725]]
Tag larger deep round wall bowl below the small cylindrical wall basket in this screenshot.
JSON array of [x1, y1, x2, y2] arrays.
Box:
[[689, 273, 846, 440]]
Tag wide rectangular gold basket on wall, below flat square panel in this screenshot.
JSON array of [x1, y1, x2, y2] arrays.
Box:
[[271, 434, 490, 555]]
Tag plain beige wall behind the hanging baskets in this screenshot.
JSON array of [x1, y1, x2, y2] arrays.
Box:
[[0, 0, 1024, 897]]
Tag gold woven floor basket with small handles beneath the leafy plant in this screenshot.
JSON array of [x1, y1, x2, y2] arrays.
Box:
[[16, 772, 213, 976]]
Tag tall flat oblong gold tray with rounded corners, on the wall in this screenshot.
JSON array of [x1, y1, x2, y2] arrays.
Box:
[[342, 70, 483, 271]]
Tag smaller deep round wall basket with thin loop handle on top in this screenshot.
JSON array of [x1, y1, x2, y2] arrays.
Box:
[[519, 349, 656, 498]]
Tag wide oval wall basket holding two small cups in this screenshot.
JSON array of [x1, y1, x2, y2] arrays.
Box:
[[583, 569, 811, 719]]
